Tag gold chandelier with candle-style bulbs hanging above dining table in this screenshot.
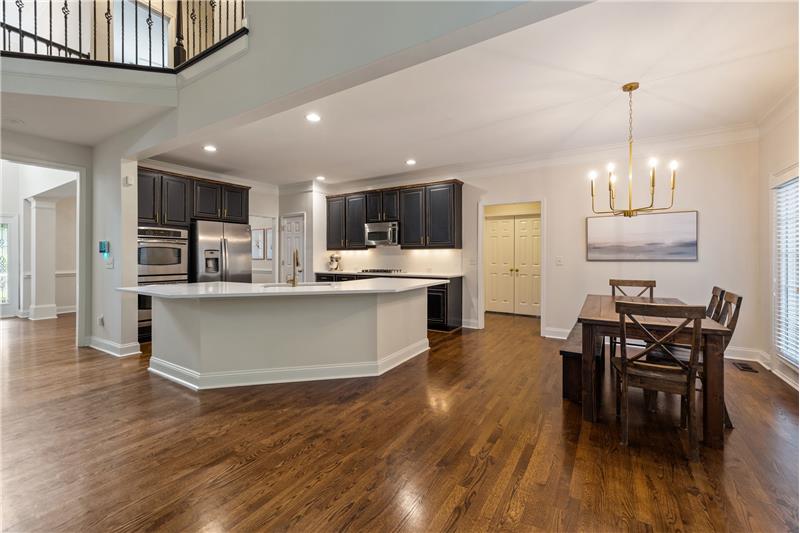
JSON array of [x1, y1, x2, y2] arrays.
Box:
[[589, 81, 678, 217]]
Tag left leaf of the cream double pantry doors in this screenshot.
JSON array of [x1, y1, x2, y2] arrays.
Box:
[[484, 216, 514, 313]]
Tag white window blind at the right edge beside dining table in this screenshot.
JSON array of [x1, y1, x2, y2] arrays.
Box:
[[773, 178, 800, 366]]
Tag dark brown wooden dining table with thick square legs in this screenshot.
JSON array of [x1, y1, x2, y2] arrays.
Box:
[[578, 294, 731, 448]]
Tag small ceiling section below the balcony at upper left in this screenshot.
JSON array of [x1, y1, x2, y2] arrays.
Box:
[[0, 92, 166, 146]]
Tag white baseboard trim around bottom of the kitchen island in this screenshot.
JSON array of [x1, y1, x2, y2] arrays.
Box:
[[148, 338, 429, 390]]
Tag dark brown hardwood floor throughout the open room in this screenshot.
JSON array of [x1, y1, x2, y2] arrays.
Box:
[[0, 315, 798, 532]]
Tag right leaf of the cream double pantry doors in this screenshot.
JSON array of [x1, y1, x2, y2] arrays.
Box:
[[514, 216, 542, 315]]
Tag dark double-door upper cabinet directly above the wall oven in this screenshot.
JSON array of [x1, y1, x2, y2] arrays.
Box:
[[138, 170, 191, 226]]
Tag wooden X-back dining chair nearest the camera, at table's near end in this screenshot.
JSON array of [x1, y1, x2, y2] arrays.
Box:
[[611, 302, 706, 461]]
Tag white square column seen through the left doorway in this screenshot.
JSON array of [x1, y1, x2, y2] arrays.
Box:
[[28, 197, 56, 320]]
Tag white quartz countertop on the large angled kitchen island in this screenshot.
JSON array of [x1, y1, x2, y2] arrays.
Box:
[[117, 278, 449, 299]]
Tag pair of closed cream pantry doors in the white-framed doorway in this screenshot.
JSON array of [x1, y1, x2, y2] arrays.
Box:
[[485, 215, 542, 316]]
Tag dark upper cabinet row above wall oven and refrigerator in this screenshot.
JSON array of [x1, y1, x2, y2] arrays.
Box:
[[138, 169, 249, 226]]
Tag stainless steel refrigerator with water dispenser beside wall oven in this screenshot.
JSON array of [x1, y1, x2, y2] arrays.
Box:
[[189, 220, 253, 283]]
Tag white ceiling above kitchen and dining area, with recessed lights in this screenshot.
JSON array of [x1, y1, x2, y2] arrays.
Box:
[[156, 2, 798, 184]]
